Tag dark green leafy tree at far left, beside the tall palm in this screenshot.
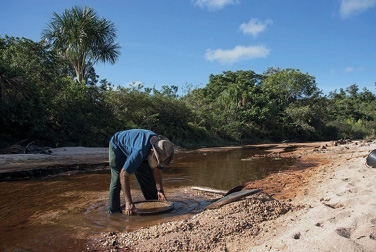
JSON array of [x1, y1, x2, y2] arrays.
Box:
[[0, 36, 67, 144]]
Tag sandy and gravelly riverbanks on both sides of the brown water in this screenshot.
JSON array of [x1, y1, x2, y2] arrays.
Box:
[[0, 141, 376, 251]]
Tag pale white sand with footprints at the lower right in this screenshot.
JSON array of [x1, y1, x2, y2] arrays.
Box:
[[244, 143, 376, 252]]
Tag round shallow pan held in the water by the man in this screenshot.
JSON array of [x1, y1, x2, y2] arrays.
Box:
[[134, 200, 174, 215]]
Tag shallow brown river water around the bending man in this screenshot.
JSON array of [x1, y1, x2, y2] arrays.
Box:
[[0, 148, 297, 251]]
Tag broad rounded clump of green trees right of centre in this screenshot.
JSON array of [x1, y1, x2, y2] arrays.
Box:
[[184, 69, 325, 142]]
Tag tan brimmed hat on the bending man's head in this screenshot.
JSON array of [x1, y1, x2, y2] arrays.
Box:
[[152, 135, 174, 167]]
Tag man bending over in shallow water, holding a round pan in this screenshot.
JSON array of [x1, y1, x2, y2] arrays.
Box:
[[109, 129, 174, 215]]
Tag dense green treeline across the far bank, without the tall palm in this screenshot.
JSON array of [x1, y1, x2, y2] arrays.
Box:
[[0, 36, 376, 147]]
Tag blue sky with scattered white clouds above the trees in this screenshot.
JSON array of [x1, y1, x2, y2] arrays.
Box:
[[0, 0, 376, 93]]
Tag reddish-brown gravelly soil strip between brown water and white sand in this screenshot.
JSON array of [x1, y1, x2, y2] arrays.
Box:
[[91, 143, 338, 251]]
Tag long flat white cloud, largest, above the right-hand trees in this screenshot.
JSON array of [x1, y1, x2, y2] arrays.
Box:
[[205, 46, 270, 64]]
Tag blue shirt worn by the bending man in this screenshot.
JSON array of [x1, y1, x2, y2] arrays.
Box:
[[110, 129, 157, 173]]
